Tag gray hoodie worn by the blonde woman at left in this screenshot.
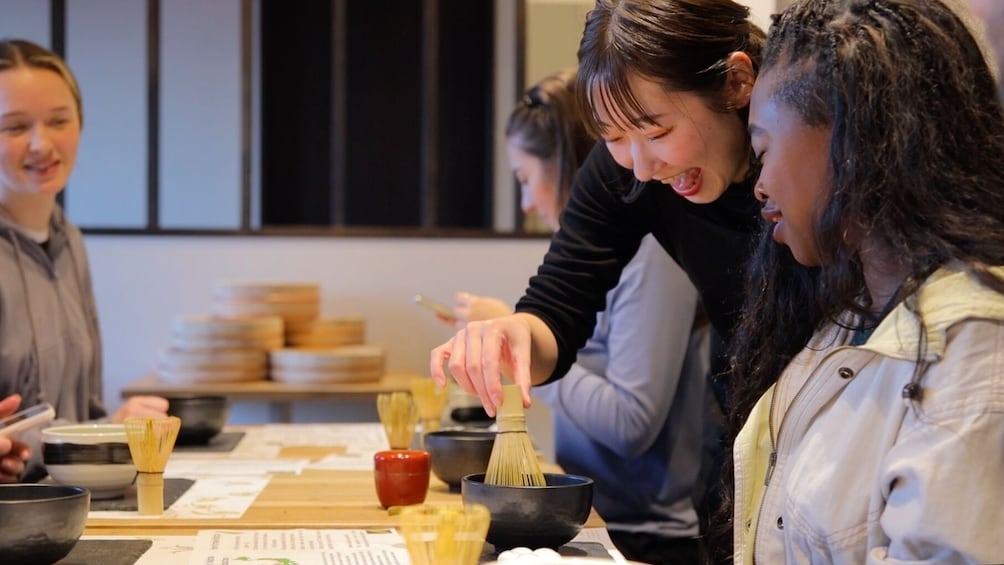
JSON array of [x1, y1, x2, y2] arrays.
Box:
[[0, 205, 106, 480]]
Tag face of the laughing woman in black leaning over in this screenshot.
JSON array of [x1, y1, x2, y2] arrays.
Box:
[[592, 69, 749, 204]]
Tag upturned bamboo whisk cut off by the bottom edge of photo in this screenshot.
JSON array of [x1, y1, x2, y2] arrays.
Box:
[[400, 504, 491, 565]]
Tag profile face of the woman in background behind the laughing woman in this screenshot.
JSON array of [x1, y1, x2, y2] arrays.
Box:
[[506, 136, 561, 231]]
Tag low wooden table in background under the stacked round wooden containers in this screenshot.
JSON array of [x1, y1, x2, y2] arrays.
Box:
[[121, 372, 421, 422]]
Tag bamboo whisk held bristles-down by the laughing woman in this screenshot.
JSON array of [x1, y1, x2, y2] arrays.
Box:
[[485, 384, 545, 487]]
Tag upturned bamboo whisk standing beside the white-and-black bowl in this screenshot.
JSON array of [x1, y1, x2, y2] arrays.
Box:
[[124, 415, 182, 516]]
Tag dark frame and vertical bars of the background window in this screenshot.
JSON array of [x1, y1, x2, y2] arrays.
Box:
[[49, 0, 544, 239]]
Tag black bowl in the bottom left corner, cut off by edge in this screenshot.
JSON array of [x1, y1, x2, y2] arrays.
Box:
[[0, 484, 90, 565]]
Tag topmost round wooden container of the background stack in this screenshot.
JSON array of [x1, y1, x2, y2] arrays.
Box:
[[213, 282, 320, 324]]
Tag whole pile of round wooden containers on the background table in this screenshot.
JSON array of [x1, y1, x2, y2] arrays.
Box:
[[158, 282, 386, 384]]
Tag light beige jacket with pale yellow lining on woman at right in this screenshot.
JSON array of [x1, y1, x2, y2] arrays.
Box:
[[734, 268, 1004, 565]]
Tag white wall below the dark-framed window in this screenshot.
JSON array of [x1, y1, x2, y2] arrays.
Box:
[[85, 235, 551, 454]]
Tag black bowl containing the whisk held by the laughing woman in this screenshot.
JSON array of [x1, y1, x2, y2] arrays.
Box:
[[461, 473, 592, 551]]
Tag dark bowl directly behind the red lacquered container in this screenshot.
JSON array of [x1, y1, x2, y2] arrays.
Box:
[[422, 430, 495, 493]]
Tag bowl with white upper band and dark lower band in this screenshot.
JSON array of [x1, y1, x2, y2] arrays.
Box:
[[42, 423, 136, 500]]
